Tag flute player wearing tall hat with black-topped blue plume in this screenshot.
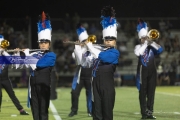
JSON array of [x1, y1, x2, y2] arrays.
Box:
[[85, 6, 120, 120]]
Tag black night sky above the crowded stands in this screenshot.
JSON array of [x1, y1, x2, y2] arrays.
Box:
[[0, 0, 180, 18]]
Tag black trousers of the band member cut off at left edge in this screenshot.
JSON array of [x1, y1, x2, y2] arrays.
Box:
[[0, 79, 23, 110]]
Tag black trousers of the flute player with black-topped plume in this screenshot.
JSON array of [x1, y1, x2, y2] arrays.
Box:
[[92, 71, 115, 120]]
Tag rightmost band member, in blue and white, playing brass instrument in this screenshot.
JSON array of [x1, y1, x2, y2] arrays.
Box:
[[134, 19, 163, 119]]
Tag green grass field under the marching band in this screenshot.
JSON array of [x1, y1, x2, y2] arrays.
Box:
[[0, 86, 180, 120]]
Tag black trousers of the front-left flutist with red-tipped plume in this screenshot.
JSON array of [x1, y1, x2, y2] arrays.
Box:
[[30, 84, 50, 120]]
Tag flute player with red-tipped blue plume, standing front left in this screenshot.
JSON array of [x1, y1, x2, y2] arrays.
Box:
[[24, 12, 56, 120]]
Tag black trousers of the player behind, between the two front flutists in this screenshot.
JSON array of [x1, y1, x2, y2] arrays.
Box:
[[71, 68, 91, 113]]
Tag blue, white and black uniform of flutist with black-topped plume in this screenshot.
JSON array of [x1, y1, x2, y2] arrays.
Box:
[[87, 43, 120, 120]]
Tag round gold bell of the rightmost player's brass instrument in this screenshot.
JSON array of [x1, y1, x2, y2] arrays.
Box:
[[147, 29, 160, 40]]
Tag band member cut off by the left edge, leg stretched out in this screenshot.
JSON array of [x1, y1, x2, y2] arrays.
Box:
[[0, 35, 29, 115]]
